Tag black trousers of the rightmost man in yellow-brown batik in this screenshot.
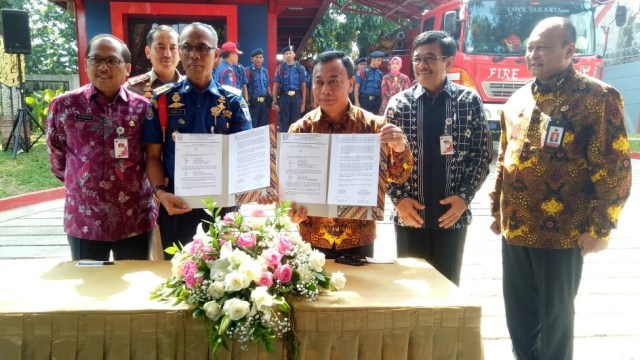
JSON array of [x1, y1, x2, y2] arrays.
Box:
[[502, 238, 583, 360]]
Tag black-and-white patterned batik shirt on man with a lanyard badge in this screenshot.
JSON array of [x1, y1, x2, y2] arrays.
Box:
[[386, 80, 493, 229]]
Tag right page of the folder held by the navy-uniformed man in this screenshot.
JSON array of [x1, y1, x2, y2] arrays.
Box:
[[229, 126, 271, 194]]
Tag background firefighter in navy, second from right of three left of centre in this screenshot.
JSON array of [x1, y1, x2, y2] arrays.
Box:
[[246, 48, 273, 128]]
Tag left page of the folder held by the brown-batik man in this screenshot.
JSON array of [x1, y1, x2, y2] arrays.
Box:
[[278, 133, 331, 204]]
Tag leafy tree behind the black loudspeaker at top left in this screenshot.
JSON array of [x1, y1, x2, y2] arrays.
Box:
[[0, 0, 78, 75]]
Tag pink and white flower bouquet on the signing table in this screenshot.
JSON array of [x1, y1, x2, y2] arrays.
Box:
[[152, 202, 346, 357]]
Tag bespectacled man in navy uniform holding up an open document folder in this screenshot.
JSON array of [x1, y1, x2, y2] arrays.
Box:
[[142, 22, 251, 260]]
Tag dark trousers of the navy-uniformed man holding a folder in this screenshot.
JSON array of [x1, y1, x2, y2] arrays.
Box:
[[158, 206, 236, 260]]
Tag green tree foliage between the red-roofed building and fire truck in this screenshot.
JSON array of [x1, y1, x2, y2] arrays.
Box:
[[305, 0, 400, 57]]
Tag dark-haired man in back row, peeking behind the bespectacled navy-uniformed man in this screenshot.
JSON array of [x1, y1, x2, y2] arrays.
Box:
[[125, 25, 181, 99]]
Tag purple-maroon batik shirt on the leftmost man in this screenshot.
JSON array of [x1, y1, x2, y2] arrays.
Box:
[[47, 84, 156, 241]]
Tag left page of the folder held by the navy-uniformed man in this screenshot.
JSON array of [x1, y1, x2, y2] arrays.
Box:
[[175, 134, 223, 196]]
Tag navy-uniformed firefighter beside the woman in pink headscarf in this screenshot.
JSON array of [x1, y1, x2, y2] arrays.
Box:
[[354, 50, 384, 114]]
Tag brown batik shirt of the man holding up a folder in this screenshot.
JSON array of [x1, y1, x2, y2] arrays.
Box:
[[289, 106, 413, 249]]
